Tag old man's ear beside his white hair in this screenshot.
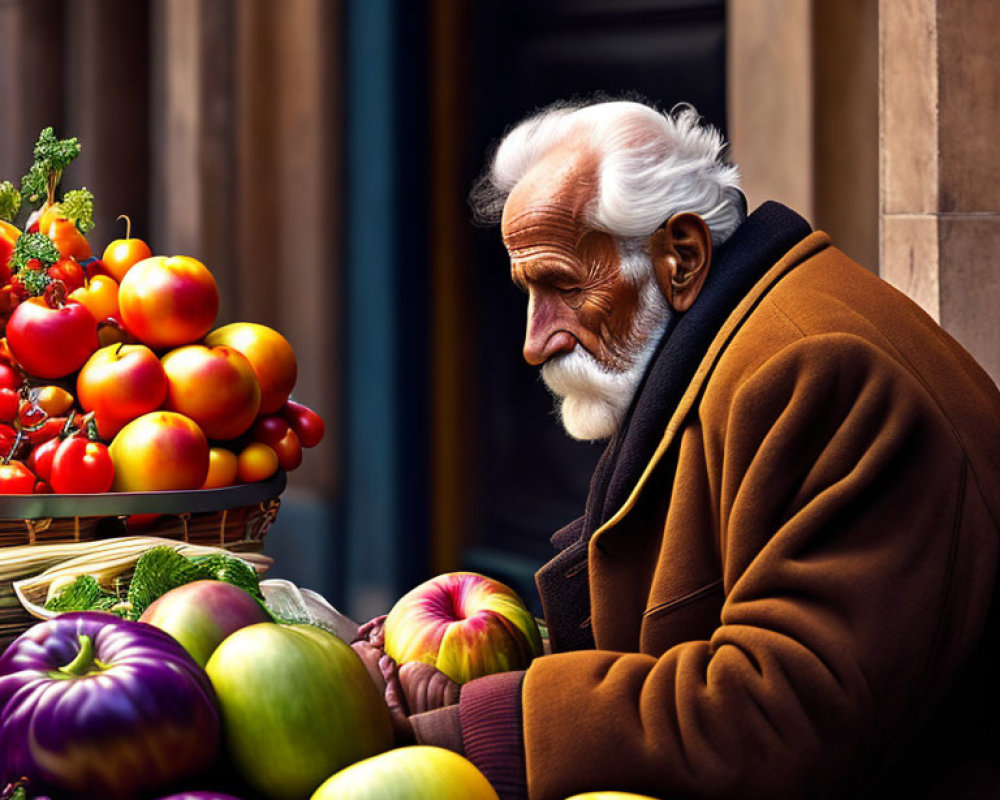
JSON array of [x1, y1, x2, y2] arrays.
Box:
[[649, 213, 712, 311]]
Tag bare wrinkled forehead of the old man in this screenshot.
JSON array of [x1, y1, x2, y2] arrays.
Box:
[[500, 145, 597, 250]]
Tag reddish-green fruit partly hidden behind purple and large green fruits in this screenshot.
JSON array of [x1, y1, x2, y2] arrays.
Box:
[[139, 580, 271, 667]]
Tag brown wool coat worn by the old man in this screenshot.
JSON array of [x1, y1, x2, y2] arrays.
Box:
[[523, 233, 1000, 800]]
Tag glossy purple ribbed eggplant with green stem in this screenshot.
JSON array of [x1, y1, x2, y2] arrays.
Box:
[[0, 612, 219, 800]]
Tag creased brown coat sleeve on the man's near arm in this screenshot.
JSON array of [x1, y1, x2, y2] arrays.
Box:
[[523, 335, 993, 800]]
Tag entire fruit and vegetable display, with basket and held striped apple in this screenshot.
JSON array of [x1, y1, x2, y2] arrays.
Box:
[[0, 128, 542, 800]]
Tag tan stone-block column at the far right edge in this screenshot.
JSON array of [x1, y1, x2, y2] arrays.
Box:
[[879, 0, 1000, 380]]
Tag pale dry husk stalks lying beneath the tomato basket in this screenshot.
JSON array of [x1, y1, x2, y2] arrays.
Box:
[[9, 536, 271, 624]]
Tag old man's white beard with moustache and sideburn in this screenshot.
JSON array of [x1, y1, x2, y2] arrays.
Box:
[[542, 270, 671, 441]]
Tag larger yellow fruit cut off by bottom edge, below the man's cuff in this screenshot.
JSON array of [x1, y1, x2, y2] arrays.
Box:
[[311, 745, 498, 800]]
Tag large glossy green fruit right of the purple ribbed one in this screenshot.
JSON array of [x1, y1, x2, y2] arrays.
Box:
[[205, 622, 393, 800]]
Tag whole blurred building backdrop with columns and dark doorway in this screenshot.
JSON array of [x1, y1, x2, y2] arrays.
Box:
[[0, 0, 1000, 618]]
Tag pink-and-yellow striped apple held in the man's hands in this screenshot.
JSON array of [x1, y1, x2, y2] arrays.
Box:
[[385, 572, 542, 684]]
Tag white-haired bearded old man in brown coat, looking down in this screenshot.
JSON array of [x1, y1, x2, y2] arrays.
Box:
[[358, 103, 1000, 800]]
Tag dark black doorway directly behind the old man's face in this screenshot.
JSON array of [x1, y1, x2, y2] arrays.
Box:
[[432, 0, 726, 612]]
